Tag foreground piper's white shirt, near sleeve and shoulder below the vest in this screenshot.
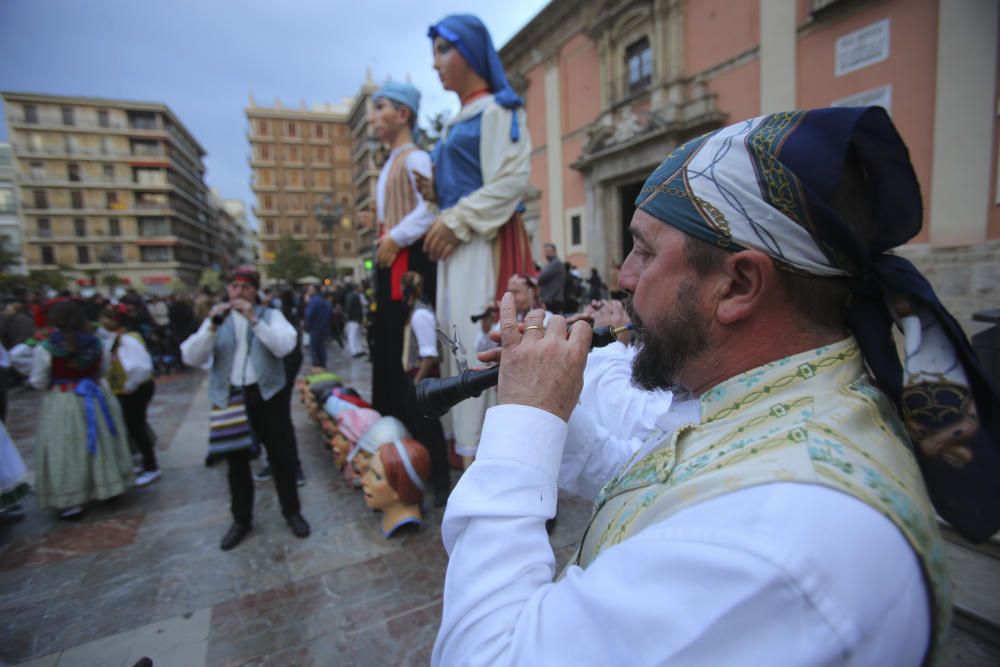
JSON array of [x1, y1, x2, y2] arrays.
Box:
[[432, 405, 930, 667]]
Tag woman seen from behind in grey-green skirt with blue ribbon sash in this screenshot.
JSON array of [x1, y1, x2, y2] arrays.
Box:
[[29, 301, 132, 519]]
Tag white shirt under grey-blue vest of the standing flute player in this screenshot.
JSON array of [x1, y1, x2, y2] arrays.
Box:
[[181, 308, 298, 387]]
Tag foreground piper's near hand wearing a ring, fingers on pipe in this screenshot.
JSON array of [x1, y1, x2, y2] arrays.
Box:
[[494, 292, 592, 421]]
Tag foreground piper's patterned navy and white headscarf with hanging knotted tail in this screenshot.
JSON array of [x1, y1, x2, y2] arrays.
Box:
[[635, 107, 1000, 540]]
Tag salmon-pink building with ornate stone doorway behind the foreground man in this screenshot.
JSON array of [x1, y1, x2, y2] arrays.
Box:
[[500, 0, 1000, 331]]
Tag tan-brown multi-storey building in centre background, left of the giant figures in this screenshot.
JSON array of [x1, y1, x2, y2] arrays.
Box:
[[246, 96, 363, 276]]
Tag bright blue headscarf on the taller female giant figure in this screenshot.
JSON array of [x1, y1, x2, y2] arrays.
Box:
[[427, 14, 524, 141]]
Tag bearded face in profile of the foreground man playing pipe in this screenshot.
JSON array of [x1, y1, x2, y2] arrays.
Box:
[[619, 210, 711, 390]]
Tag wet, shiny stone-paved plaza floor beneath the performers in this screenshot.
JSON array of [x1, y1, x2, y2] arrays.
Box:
[[0, 346, 589, 667]]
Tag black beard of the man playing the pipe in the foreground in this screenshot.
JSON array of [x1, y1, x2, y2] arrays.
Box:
[[624, 282, 709, 391]]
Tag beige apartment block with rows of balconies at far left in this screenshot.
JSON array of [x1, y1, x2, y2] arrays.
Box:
[[0, 92, 220, 293]]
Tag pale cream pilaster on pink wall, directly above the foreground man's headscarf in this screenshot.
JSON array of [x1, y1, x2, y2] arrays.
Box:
[[758, 0, 797, 114]]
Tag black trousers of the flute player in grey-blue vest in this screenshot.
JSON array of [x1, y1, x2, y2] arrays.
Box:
[[226, 384, 301, 525]]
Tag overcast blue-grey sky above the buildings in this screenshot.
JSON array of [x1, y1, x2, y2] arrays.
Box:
[[0, 0, 547, 230]]
